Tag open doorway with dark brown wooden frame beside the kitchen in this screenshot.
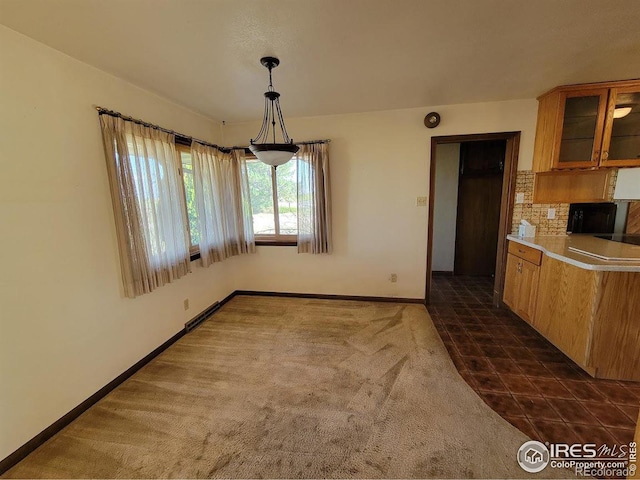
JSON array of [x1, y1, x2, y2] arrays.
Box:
[[425, 132, 520, 305]]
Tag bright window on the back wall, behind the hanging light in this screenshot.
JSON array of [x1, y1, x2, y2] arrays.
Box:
[[247, 157, 298, 245]]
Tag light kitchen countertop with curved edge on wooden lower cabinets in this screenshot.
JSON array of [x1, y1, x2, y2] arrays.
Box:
[[507, 234, 640, 272]]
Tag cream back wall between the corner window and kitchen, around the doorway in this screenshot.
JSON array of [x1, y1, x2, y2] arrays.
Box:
[[224, 99, 537, 298]]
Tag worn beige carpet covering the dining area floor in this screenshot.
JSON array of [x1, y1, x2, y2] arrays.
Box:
[[5, 297, 570, 478]]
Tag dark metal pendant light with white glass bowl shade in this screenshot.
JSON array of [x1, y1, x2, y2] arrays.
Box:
[[249, 57, 298, 167]]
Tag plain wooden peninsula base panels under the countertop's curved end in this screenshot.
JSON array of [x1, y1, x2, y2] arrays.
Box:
[[532, 256, 640, 381]]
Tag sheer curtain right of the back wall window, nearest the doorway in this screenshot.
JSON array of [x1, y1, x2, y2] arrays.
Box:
[[297, 143, 332, 253]]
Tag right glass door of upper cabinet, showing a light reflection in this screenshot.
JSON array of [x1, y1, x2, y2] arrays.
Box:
[[601, 87, 640, 167]]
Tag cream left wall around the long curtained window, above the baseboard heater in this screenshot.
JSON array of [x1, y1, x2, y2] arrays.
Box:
[[0, 26, 234, 459]]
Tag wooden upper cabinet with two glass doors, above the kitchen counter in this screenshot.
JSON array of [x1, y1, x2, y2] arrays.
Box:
[[533, 80, 640, 172]]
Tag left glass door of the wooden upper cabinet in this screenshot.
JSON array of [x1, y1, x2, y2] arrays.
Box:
[[553, 89, 608, 168]]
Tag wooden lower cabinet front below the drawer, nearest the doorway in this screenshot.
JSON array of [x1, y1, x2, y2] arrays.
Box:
[[502, 253, 540, 323]]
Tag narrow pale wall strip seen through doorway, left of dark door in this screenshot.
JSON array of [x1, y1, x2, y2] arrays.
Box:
[[432, 143, 460, 272]]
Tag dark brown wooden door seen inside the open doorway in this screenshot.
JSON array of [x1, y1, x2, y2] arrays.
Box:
[[454, 140, 506, 276]]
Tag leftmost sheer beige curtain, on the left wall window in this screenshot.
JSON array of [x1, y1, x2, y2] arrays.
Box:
[[100, 114, 191, 298]]
